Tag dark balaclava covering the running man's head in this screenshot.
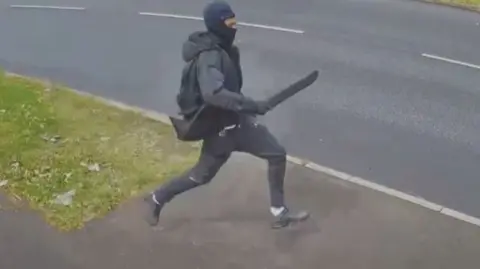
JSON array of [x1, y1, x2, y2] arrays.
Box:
[[203, 1, 237, 49]]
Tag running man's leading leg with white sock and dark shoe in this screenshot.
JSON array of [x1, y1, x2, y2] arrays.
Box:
[[236, 119, 309, 228]]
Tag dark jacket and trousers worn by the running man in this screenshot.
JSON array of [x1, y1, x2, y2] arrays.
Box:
[[155, 24, 286, 207]]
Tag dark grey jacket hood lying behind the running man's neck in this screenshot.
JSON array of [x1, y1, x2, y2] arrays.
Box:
[[182, 32, 220, 62]]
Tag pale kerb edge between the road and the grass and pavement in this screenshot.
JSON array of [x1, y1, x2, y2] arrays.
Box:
[[5, 72, 480, 227]]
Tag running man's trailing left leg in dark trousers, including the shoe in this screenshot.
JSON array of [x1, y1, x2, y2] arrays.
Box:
[[142, 133, 233, 226]]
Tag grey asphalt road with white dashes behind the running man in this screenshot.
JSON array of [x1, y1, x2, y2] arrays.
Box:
[[0, 0, 480, 217]]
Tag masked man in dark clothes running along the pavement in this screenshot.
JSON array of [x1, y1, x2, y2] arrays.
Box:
[[147, 1, 309, 228]]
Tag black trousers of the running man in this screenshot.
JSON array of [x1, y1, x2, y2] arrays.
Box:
[[155, 117, 286, 207]]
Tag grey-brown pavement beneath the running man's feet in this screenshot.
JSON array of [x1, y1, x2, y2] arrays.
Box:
[[0, 154, 480, 269]]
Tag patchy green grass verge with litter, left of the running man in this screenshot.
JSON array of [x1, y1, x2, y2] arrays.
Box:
[[0, 71, 198, 230]]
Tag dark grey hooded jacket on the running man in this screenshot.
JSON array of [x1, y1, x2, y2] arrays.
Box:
[[177, 32, 257, 129]]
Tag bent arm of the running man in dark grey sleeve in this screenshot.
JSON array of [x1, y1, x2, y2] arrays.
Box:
[[197, 52, 257, 113]]
